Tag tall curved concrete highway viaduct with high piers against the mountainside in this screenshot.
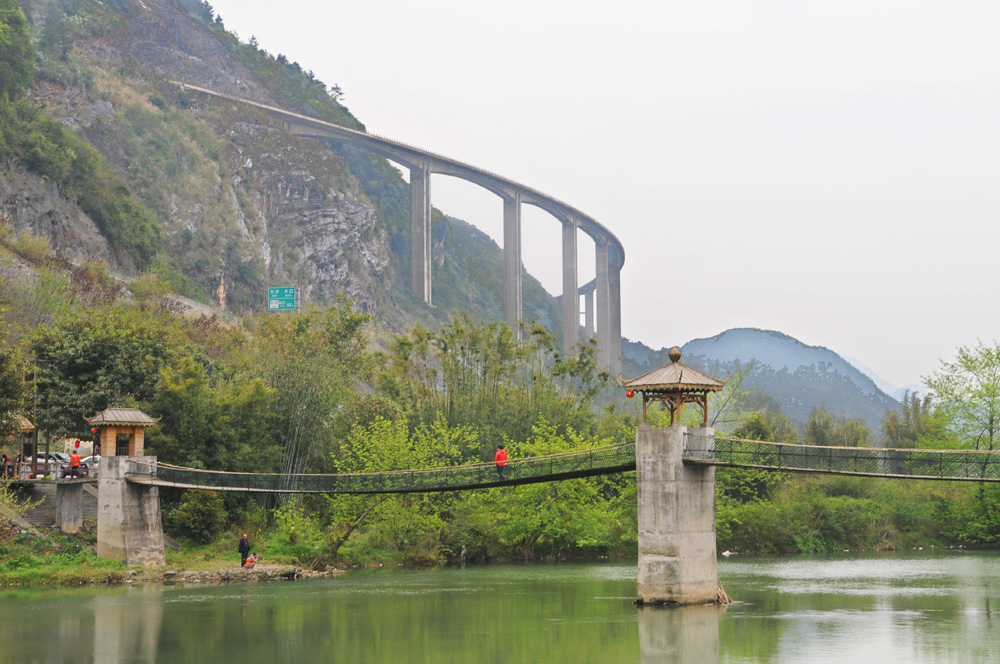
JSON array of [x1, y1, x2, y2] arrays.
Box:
[[171, 81, 625, 374]]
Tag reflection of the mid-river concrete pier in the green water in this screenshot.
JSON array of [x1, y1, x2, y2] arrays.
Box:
[[638, 605, 726, 664]]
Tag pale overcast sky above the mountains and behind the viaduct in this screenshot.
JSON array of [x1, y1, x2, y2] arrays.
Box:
[[210, 0, 1000, 386]]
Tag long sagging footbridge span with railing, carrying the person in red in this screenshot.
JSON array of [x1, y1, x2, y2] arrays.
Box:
[[127, 443, 635, 493]]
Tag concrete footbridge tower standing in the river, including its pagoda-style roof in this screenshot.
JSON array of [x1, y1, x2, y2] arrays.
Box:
[[625, 347, 725, 604]]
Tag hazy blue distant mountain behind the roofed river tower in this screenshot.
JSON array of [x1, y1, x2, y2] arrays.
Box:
[[622, 328, 900, 433]]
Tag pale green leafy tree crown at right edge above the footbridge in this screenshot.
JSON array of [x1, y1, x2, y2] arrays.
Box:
[[924, 341, 1000, 450]]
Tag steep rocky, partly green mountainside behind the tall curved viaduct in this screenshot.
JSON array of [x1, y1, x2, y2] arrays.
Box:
[[0, 0, 561, 331]]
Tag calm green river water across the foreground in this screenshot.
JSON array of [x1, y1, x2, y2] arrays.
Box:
[[0, 551, 1000, 664]]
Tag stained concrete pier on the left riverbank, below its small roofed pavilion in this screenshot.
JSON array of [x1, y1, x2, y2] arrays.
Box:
[[97, 456, 167, 565]]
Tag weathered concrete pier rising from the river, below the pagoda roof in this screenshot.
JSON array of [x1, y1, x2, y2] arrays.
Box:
[[635, 422, 719, 604]]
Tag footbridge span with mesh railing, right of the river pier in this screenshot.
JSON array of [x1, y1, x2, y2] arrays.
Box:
[[683, 434, 1000, 482]]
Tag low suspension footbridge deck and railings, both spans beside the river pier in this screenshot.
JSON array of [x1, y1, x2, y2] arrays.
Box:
[[121, 434, 1000, 494]]
